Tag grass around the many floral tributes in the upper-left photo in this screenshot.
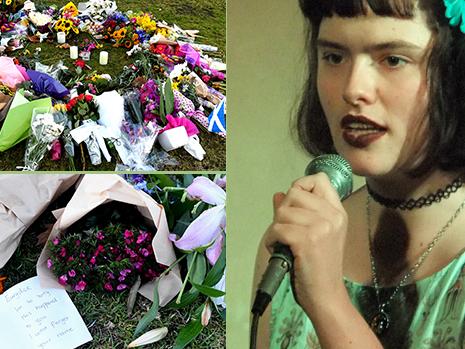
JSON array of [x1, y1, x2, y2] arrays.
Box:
[[0, 0, 226, 171]]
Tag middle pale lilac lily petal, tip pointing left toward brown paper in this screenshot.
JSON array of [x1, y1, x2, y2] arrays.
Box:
[[170, 205, 226, 251]]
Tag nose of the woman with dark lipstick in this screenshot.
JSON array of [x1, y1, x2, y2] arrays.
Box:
[[342, 60, 377, 106]]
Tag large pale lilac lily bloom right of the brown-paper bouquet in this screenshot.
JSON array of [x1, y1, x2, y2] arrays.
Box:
[[170, 176, 226, 265]]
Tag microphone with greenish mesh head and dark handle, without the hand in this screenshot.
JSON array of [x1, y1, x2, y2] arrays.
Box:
[[252, 154, 352, 316]]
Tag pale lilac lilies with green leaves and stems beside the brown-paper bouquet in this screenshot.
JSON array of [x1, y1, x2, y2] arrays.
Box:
[[127, 175, 226, 348]]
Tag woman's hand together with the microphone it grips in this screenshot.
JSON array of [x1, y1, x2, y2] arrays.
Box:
[[252, 155, 352, 315]]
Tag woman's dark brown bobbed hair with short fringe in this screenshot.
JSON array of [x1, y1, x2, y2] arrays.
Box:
[[294, 0, 465, 176]]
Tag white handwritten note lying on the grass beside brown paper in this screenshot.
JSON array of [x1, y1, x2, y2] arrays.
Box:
[[0, 276, 92, 349]]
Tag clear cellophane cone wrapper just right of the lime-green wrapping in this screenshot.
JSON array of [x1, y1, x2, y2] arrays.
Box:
[[23, 107, 68, 171]]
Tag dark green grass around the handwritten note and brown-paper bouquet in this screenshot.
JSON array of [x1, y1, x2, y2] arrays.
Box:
[[0, 181, 226, 349]]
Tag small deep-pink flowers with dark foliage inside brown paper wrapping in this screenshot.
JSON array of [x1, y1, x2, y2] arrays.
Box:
[[47, 224, 165, 292]]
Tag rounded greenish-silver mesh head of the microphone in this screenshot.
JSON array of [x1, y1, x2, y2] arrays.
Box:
[[305, 154, 352, 200]]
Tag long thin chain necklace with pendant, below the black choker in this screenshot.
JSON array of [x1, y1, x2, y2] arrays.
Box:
[[366, 195, 465, 336]]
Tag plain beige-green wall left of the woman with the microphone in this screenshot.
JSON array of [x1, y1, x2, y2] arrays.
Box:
[[227, 0, 309, 349]]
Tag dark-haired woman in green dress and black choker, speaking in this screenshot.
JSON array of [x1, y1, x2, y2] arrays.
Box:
[[256, 0, 465, 349]]
